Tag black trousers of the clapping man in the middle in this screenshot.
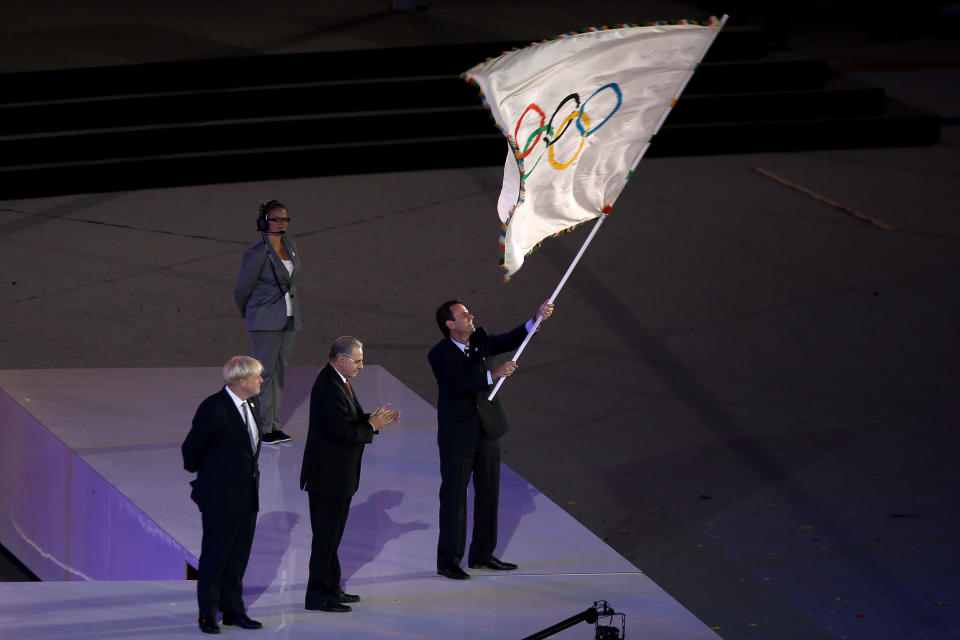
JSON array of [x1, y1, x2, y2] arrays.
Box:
[[306, 493, 352, 607]]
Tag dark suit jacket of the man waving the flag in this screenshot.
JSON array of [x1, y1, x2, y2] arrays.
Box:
[[427, 325, 527, 450]]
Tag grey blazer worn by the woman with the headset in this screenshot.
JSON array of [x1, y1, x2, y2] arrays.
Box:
[[233, 235, 300, 331]]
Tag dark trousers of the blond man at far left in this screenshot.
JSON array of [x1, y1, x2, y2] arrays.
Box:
[[197, 511, 257, 616]]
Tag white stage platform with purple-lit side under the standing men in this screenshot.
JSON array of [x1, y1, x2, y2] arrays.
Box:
[[0, 365, 717, 640]]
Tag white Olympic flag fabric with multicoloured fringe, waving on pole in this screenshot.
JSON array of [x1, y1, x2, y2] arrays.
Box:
[[463, 18, 722, 278]]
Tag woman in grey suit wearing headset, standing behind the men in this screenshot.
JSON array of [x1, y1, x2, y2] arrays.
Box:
[[233, 200, 300, 444]]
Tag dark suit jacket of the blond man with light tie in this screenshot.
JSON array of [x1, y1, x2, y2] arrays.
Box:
[[180, 389, 260, 514]]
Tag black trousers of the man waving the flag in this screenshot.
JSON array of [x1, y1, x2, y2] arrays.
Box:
[[437, 437, 500, 567]]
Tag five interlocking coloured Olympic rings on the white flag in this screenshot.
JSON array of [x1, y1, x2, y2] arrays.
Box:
[[513, 82, 623, 180]]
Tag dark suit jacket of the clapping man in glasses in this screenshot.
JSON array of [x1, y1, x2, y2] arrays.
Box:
[[300, 364, 374, 497]]
